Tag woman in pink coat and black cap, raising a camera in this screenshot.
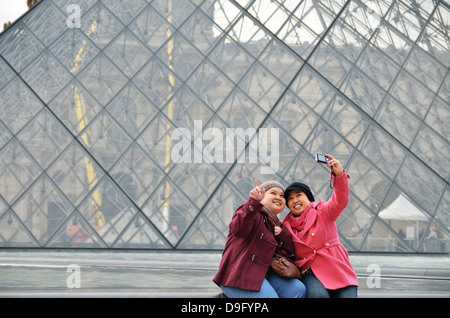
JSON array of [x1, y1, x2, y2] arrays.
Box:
[[283, 155, 358, 298]]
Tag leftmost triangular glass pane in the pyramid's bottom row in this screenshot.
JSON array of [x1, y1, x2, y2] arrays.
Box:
[[0, 210, 39, 248]]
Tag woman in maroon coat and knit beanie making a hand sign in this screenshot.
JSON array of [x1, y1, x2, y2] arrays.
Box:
[[213, 180, 305, 298]]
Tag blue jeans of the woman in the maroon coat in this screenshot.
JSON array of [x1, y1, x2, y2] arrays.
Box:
[[220, 268, 306, 298]]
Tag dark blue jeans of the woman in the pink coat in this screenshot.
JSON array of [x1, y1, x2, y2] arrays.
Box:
[[302, 273, 358, 298]]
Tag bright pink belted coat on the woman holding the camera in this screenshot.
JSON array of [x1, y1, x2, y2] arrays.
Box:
[[283, 171, 358, 290]]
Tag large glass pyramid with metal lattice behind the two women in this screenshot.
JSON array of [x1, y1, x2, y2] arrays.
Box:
[[0, 0, 450, 253]]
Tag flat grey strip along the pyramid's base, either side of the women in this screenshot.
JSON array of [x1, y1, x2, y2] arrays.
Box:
[[0, 250, 450, 298]]
